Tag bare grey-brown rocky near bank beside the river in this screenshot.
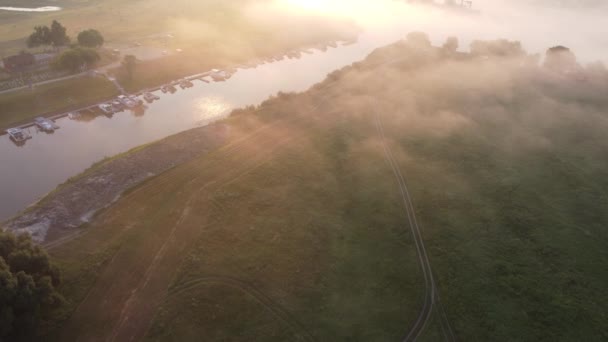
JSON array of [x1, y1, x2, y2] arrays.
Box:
[[5, 122, 230, 243]]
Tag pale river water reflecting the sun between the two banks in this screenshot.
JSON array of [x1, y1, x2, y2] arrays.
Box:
[[0, 1, 608, 221]]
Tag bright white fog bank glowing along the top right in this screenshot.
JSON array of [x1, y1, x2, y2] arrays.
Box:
[[268, 0, 608, 62]]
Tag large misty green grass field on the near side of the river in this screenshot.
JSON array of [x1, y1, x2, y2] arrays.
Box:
[[35, 42, 608, 341]]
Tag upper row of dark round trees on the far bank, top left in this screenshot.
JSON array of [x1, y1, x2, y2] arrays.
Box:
[[27, 20, 104, 48]]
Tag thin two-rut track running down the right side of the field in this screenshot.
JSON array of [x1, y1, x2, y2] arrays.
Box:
[[374, 111, 456, 342]]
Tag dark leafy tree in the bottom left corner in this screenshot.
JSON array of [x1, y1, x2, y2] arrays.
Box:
[[0, 230, 63, 340]]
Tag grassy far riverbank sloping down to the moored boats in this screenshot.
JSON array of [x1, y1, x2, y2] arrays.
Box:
[[0, 34, 353, 135]]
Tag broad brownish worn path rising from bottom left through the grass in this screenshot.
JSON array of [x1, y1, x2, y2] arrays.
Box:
[[62, 119, 294, 341]]
